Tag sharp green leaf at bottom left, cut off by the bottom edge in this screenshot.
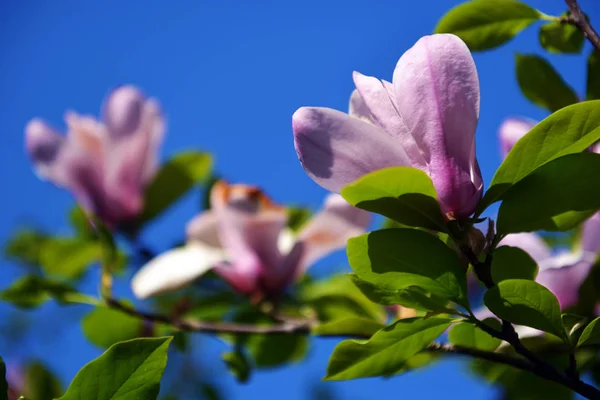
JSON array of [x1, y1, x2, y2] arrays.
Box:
[[59, 337, 171, 400]]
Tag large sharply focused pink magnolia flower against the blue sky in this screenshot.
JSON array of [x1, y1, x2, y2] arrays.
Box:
[[292, 34, 483, 219]]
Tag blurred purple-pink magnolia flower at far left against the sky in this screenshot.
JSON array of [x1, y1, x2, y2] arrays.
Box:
[[25, 86, 164, 226]]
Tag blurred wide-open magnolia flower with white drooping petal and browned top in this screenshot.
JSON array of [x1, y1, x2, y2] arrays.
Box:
[[132, 181, 370, 298]]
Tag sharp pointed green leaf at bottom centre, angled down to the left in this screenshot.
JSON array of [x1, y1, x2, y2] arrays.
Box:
[[325, 318, 453, 380]]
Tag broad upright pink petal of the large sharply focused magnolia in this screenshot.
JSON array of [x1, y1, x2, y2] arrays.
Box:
[[393, 34, 483, 218]]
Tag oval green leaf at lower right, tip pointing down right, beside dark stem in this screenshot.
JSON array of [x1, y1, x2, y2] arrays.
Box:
[[483, 279, 568, 341]]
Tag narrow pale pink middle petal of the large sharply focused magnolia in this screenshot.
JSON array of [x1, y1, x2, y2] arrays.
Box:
[[352, 71, 426, 166]]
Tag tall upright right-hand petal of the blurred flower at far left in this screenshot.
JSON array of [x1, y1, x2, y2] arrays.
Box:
[[103, 86, 164, 217]]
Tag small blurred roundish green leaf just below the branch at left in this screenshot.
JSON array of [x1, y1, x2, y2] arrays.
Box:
[[81, 307, 144, 348]]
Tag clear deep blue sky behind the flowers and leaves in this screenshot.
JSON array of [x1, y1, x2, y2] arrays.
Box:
[[0, 0, 600, 400]]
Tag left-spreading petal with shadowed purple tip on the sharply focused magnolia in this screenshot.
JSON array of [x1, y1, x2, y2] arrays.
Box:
[[292, 107, 410, 193]]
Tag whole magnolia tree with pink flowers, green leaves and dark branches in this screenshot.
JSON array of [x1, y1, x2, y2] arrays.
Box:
[[5, 0, 600, 400]]
